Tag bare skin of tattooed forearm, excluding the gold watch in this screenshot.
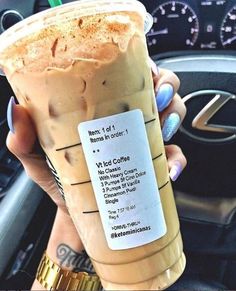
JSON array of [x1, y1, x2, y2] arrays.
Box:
[[31, 209, 94, 290]]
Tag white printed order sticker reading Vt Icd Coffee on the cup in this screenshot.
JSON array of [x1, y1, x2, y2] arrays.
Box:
[[78, 109, 166, 250]]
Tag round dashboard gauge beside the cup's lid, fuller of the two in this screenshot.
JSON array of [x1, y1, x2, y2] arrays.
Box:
[[147, 1, 199, 53]]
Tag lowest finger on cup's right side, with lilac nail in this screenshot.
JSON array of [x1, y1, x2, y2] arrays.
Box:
[[165, 145, 187, 181]]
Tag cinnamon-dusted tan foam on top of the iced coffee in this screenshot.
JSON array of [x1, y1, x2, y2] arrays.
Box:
[[0, 12, 143, 72]]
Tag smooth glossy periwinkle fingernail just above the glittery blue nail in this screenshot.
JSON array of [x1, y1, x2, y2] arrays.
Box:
[[156, 83, 174, 112]]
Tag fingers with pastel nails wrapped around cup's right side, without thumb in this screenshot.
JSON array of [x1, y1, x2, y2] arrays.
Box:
[[151, 60, 187, 181]]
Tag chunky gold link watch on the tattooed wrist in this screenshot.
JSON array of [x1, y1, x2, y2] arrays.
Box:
[[36, 253, 102, 291]]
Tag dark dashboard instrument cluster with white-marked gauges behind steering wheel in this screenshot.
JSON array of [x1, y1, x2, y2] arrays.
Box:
[[142, 0, 236, 55]]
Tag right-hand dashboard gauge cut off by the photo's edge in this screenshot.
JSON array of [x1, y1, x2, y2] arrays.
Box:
[[220, 6, 236, 49]]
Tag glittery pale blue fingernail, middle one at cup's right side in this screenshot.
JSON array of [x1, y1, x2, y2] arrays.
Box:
[[162, 112, 181, 141]]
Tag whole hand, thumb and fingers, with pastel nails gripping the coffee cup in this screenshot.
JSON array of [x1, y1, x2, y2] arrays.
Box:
[[7, 64, 186, 213]]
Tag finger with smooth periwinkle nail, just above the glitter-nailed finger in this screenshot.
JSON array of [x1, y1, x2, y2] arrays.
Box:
[[153, 69, 180, 112]]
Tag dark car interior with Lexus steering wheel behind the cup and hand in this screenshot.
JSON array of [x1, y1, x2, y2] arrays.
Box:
[[0, 0, 236, 290]]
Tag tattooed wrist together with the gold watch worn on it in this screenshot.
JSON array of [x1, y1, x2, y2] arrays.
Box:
[[32, 209, 101, 291]]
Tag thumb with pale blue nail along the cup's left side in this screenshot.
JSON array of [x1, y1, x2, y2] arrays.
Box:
[[6, 99, 67, 212]]
